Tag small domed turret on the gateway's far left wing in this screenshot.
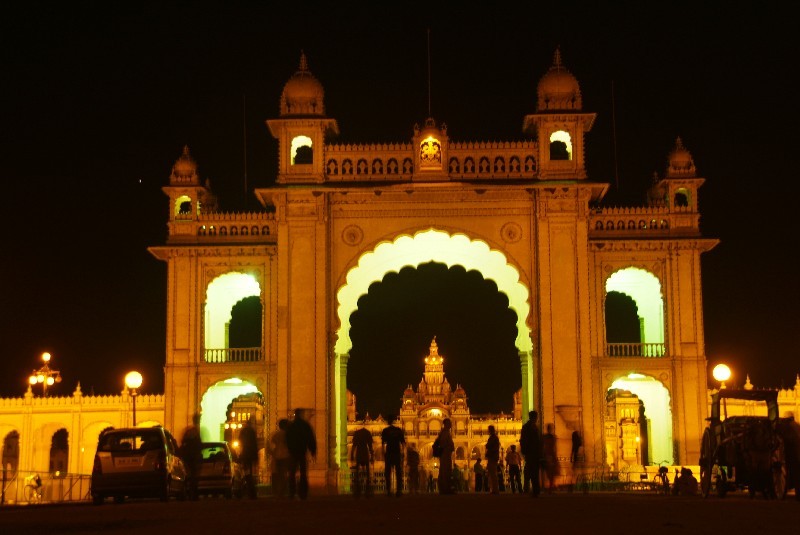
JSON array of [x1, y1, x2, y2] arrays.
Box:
[[162, 146, 217, 227]]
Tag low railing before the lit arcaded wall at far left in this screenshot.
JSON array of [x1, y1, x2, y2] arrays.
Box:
[[0, 469, 92, 505]]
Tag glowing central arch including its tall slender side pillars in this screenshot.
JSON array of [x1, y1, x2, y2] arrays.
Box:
[[334, 228, 533, 472]]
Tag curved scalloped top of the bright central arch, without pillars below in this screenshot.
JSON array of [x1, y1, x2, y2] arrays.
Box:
[[335, 229, 533, 355]]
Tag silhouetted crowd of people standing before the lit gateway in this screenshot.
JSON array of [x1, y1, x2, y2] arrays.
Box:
[[181, 409, 720, 500]]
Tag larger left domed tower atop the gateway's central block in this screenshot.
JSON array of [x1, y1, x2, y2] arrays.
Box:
[[267, 52, 339, 184]]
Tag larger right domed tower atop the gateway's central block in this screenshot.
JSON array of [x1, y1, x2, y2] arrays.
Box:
[[522, 49, 597, 180]]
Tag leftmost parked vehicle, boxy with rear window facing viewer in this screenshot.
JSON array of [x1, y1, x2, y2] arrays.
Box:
[[91, 426, 186, 505]]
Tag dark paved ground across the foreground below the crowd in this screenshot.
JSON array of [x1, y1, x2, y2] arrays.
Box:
[[0, 493, 800, 535]]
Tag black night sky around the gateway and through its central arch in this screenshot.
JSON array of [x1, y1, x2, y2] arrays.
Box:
[[0, 2, 800, 414]]
